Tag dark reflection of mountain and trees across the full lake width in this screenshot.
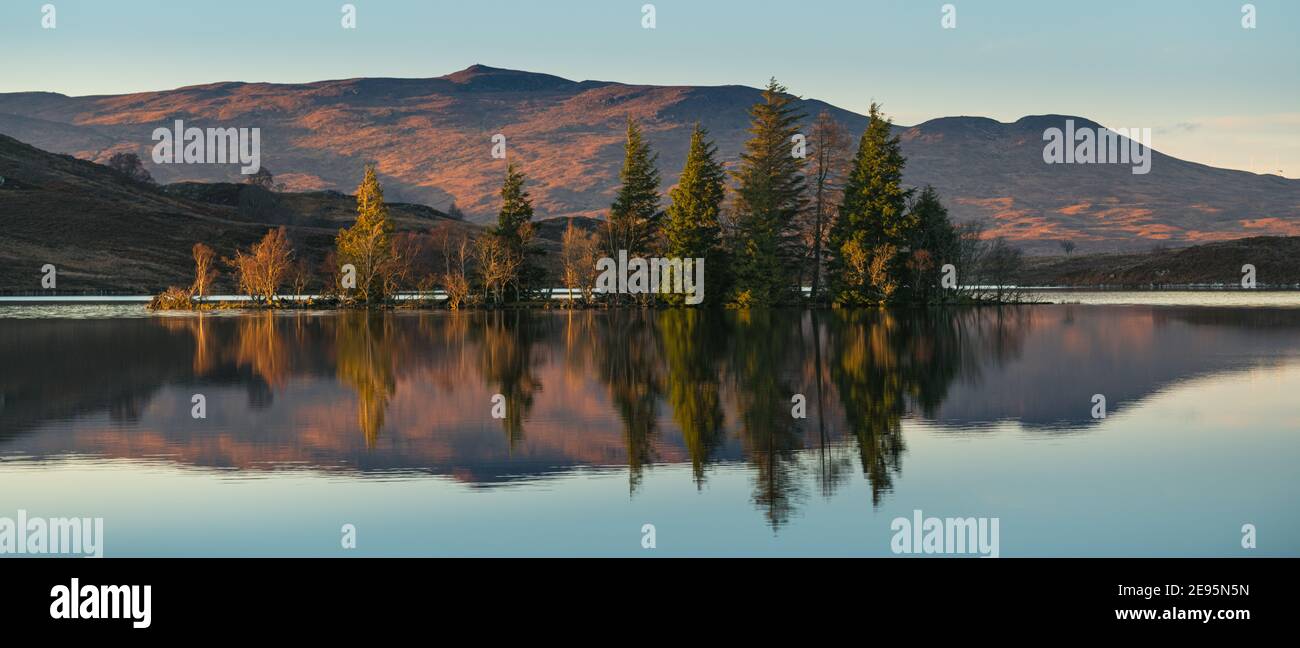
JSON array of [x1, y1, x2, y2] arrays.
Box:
[[0, 306, 1300, 528]]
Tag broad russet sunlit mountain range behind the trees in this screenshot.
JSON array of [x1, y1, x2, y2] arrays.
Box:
[[0, 65, 1300, 252]]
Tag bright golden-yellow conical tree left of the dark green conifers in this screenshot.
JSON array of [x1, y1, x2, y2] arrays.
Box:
[[334, 164, 395, 303]]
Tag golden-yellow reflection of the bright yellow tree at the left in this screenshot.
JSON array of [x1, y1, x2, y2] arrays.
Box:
[[334, 312, 399, 448]]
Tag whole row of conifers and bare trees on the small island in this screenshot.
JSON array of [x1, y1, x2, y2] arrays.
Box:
[[155, 79, 1023, 308]]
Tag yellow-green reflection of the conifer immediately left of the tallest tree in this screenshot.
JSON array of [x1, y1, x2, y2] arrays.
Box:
[[658, 308, 725, 487]]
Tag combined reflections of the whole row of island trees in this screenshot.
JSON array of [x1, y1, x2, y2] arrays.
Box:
[[122, 308, 1034, 530]]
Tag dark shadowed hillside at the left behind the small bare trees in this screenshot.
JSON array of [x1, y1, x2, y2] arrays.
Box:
[[0, 135, 467, 294]]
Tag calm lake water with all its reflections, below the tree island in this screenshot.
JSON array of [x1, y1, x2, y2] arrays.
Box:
[[0, 297, 1300, 556]]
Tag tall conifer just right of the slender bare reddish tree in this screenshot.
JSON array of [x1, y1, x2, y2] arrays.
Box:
[[827, 103, 915, 304]]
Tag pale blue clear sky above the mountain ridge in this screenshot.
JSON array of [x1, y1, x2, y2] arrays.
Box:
[[0, 0, 1300, 178]]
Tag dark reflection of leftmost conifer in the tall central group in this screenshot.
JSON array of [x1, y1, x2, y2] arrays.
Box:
[[595, 310, 663, 491]]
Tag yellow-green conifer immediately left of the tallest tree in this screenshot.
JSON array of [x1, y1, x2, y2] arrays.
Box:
[[663, 122, 727, 304]]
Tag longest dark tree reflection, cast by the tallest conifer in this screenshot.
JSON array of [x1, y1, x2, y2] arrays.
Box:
[[731, 308, 803, 530]]
